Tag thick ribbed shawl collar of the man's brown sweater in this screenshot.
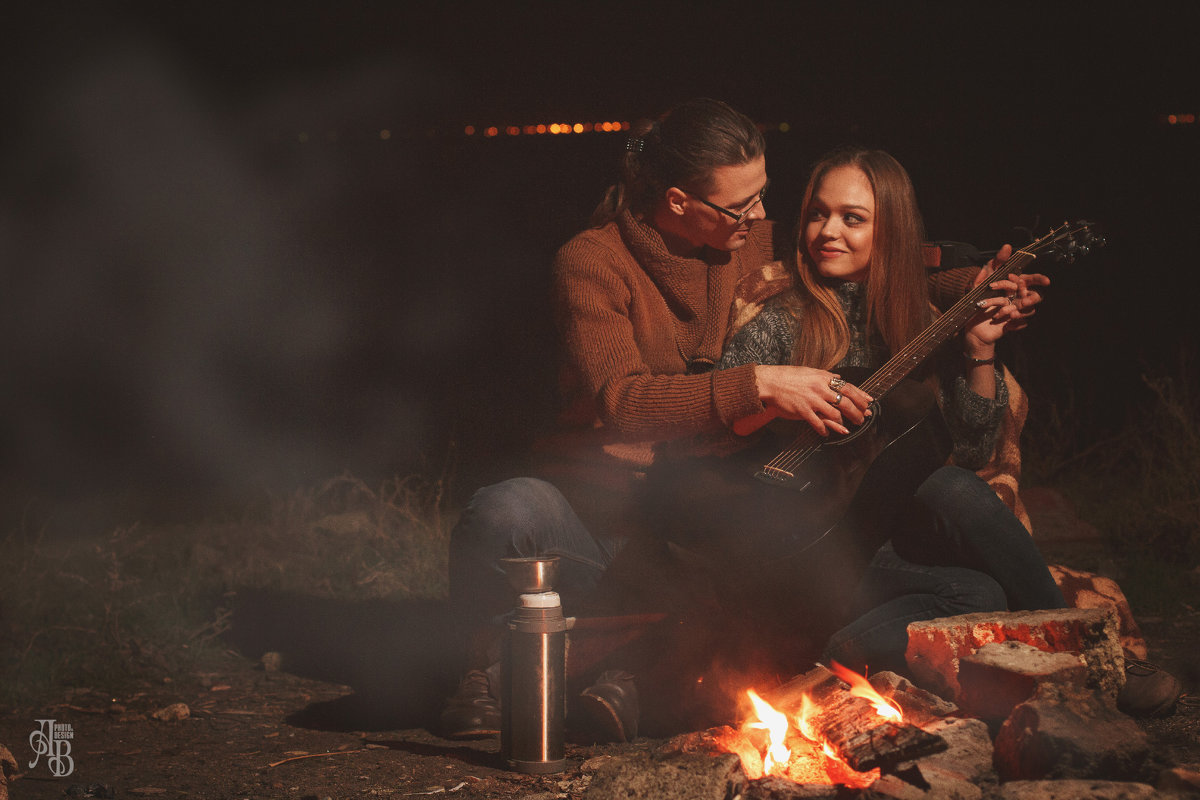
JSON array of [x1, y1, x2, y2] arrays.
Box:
[[617, 209, 732, 319]]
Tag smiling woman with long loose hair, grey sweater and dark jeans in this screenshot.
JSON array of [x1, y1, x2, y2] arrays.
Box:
[[719, 150, 1066, 673]]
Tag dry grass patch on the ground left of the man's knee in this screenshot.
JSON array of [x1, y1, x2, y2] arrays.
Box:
[[0, 476, 449, 708]]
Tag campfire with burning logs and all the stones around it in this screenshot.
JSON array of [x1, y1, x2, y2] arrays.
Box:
[[588, 608, 1171, 800]]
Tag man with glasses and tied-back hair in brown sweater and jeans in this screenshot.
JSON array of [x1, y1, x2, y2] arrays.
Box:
[[440, 100, 796, 741]]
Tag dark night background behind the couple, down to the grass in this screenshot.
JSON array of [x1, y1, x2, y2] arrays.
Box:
[[0, 0, 1200, 532]]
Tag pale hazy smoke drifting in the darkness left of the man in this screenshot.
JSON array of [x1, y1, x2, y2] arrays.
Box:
[[0, 25, 470, 527]]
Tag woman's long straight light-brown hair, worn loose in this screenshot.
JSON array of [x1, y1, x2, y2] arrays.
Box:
[[792, 149, 930, 369]]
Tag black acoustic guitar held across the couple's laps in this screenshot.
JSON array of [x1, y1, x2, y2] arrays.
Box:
[[649, 222, 1104, 566]]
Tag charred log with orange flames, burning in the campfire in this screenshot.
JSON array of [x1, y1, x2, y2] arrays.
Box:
[[768, 664, 947, 772]]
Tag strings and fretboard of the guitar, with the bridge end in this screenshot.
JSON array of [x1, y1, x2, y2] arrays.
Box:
[[763, 225, 1086, 474]]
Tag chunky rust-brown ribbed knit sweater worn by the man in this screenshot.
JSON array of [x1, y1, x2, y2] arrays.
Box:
[[540, 211, 776, 532]]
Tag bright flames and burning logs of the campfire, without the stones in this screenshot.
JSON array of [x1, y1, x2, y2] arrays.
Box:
[[714, 662, 940, 788]]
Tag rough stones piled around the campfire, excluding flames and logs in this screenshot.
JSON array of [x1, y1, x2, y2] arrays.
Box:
[[586, 608, 1200, 800]]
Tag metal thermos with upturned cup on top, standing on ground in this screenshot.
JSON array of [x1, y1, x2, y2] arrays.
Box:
[[500, 557, 566, 772]]
